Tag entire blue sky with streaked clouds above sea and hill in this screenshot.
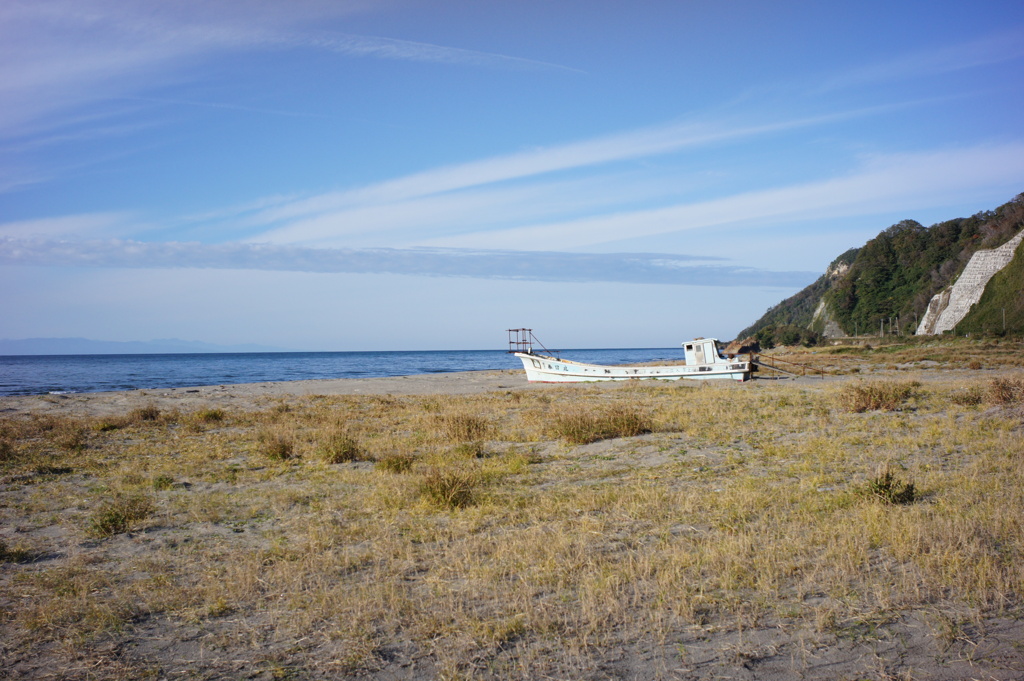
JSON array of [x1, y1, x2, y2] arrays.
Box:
[[0, 0, 1024, 350]]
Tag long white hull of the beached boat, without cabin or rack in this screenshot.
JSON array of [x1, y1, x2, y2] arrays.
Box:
[[514, 352, 751, 383]]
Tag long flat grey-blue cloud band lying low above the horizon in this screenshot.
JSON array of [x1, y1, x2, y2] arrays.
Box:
[[0, 237, 816, 288]]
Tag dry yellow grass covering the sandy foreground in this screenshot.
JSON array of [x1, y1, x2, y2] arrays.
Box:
[[0, 348, 1024, 679]]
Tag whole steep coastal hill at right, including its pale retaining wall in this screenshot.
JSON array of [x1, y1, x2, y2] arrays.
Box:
[[737, 194, 1024, 347]]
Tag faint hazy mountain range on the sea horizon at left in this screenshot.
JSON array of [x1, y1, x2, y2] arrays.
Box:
[[0, 338, 292, 354]]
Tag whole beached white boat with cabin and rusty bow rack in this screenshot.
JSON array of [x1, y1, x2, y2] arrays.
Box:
[[508, 329, 752, 383]]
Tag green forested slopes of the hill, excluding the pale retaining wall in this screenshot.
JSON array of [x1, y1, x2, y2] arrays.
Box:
[[738, 195, 1024, 346]]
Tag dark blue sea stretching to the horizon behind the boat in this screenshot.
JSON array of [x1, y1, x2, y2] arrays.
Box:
[[0, 347, 683, 395]]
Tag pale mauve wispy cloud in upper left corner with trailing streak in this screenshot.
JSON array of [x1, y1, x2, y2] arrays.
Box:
[[0, 0, 574, 137]]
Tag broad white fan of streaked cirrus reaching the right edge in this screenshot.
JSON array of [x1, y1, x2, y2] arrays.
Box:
[[244, 119, 1024, 250]]
